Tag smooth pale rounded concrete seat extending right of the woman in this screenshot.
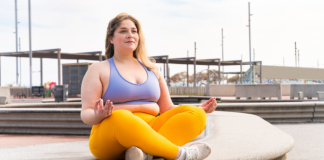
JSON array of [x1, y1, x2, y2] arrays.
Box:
[[187, 111, 294, 160]]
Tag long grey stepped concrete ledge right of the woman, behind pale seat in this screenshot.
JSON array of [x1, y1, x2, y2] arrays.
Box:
[[187, 101, 324, 123]]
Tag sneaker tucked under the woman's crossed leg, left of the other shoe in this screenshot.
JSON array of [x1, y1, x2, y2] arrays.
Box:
[[125, 146, 153, 160]]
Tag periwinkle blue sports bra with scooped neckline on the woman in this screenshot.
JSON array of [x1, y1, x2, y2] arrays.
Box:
[[102, 58, 160, 104]]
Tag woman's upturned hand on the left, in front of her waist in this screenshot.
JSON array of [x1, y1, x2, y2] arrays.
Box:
[[93, 98, 114, 119]]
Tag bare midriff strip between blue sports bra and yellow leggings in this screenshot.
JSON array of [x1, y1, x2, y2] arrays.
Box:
[[113, 103, 160, 115]]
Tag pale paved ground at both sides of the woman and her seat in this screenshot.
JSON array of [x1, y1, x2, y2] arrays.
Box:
[[0, 123, 324, 160]]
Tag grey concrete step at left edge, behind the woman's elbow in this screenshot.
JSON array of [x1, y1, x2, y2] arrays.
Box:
[[0, 108, 92, 135]]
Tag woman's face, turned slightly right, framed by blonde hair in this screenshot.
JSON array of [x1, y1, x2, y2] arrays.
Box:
[[110, 20, 139, 52]]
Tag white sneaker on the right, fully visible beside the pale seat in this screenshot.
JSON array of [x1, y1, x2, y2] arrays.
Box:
[[182, 142, 211, 160]]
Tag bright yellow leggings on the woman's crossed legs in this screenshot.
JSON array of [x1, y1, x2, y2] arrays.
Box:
[[89, 105, 207, 159]]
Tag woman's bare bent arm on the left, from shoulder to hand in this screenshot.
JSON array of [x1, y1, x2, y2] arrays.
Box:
[[81, 63, 113, 125]]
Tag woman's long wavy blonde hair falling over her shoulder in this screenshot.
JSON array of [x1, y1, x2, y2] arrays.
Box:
[[105, 13, 158, 74]]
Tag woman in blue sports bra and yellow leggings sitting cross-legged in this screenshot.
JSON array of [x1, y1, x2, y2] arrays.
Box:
[[81, 13, 217, 160]]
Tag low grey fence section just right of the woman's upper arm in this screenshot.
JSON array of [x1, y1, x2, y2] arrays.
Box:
[[169, 87, 206, 96]]
